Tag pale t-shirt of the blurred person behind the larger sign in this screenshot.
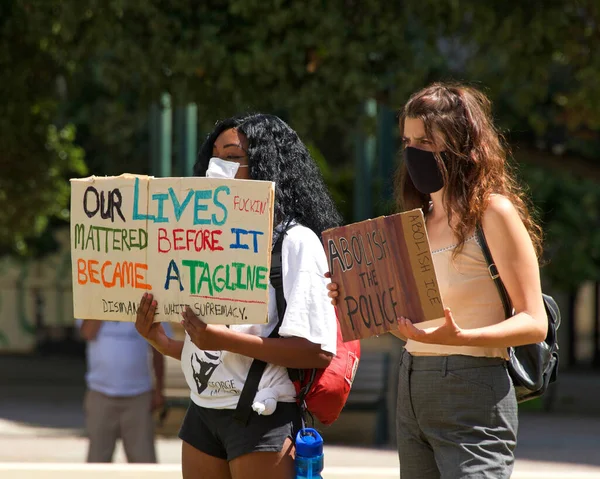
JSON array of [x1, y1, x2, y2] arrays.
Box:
[[76, 319, 171, 397]]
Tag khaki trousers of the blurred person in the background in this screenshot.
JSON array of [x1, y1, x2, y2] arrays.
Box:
[[84, 389, 156, 463]]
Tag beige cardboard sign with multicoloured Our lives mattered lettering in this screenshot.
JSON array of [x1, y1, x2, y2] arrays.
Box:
[[71, 174, 274, 324]]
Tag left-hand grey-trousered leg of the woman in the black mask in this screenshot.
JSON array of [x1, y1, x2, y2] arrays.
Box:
[[396, 351, 440, 479]]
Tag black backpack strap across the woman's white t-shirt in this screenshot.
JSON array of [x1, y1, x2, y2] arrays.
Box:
[[233, 225, 296, 426]]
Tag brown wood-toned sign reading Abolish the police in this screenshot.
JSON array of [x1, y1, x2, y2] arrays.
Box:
[[323, 209, 444, 341]]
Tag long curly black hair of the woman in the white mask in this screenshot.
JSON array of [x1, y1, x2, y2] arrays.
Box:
[[194, 113, 342, 237]]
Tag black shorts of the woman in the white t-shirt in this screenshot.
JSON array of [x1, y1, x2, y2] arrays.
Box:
[[179, 401, 302, 461]]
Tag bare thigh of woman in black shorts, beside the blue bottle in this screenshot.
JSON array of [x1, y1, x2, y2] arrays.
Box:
[[230, 437, 296, 479]]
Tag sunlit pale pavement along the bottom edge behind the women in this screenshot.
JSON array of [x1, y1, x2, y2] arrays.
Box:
[[0, 434, 600, 479]]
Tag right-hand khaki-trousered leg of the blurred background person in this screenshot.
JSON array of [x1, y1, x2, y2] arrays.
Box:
[[119, 392, 156, 463]]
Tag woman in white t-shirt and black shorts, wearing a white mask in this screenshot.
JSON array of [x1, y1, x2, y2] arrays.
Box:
[[136, 114, 341, 479]]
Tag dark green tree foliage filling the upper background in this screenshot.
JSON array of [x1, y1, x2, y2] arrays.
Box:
[[0, 0, 600, 288]]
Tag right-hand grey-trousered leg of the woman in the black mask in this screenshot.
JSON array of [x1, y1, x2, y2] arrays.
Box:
[[419, 357, 518, 479]]
